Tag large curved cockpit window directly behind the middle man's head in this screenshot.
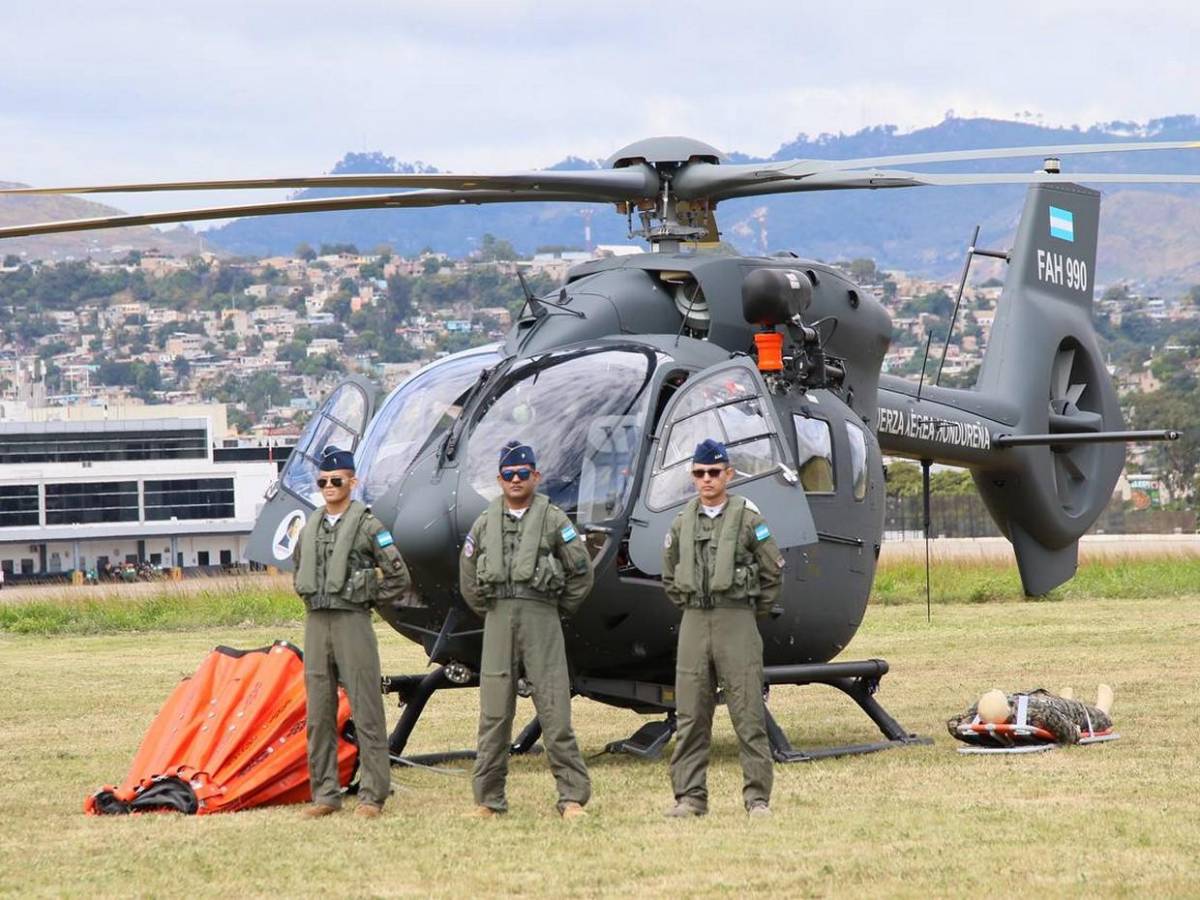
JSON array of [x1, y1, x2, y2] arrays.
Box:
[[466, 349, 659, 522]]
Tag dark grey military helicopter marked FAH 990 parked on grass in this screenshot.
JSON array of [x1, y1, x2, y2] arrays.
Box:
[[0, 137, 1200, 761]]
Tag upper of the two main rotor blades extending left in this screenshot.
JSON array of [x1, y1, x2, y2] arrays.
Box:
[[0, 164, 659, 203]]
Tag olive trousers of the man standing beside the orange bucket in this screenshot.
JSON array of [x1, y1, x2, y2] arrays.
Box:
[[304, 610, 391, 808]]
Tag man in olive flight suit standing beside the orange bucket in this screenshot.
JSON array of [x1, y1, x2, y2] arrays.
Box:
[[292, 446, 409, 818]]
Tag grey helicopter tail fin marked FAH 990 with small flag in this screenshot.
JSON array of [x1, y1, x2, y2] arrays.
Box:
[[972, 184, 1124, 595]]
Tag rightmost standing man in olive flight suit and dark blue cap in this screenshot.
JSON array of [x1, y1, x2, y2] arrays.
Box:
[[662, 439, 784, 818]]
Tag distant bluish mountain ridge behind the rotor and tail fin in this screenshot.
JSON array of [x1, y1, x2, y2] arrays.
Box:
[[206, 115, 1200, 282]]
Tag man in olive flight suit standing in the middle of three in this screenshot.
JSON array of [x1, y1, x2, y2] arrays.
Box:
[[458, 440, 592, 818]]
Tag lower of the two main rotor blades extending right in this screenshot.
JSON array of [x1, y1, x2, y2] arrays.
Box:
[[710, 169, 1200, 200]]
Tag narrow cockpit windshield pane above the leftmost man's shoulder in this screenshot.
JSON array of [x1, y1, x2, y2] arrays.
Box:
[[356, 346, 500, 504]]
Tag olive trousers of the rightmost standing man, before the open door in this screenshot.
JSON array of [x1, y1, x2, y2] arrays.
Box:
[[671, 608, 775, 810]]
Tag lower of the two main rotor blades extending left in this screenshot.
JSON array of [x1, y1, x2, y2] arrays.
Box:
[[0, 191, 607, 240]]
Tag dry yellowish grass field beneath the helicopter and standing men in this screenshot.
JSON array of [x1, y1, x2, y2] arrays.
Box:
[[0, 578, 1200, 896]]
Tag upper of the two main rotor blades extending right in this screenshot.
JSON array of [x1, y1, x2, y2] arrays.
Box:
[[673, 140, 1200, 199]]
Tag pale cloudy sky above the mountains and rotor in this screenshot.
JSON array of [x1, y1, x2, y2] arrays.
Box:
[[0, 0, 1200, 218]]
